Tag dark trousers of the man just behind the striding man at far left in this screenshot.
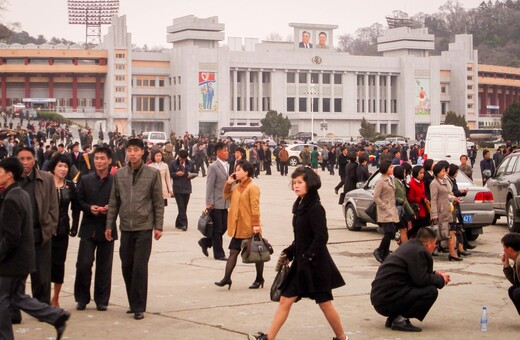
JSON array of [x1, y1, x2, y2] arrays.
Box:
[[11, 240, 52, 321]]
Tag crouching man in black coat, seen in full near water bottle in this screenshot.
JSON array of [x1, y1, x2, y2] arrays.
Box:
[[370, 228, 450, 332]]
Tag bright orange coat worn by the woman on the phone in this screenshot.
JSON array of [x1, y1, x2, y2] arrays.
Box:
[[224, 178, 260, 238]]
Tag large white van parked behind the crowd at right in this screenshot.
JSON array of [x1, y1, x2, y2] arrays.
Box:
[[424, 125, 468, 164]]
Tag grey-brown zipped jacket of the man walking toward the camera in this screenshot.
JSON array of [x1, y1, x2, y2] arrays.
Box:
[[106, 163, 164, 231]]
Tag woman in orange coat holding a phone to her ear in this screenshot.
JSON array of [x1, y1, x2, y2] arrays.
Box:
[[215, 160, 264, 289]]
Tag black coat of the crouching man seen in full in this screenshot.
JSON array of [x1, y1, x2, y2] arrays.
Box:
[[370, 239, 444, 306]]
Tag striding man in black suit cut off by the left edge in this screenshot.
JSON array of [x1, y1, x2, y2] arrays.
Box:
[[0, 157, 70, 340]]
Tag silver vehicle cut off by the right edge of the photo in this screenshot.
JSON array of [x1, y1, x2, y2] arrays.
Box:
[[486, 152, 520, 232]]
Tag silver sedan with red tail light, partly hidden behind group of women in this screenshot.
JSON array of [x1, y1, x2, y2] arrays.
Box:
[[342, 166, 494, 241]]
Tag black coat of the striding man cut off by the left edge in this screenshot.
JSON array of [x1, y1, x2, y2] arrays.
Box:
[[0, 184, 36, 276]]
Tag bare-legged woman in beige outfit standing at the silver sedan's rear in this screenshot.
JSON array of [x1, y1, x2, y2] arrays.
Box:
[[430, 162, 462, 261]]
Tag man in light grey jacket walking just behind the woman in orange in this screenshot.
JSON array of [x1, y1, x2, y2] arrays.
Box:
[[199, 142, 229, 261]]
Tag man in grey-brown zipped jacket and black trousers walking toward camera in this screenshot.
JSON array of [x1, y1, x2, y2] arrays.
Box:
[[105, 138, 164, 320]]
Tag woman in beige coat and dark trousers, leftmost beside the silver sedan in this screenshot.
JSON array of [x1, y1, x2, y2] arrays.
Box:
[[374, 161, 399, 263]]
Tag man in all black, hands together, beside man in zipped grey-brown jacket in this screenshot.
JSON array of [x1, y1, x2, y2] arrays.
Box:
[[74, 146, 117, 311]]
